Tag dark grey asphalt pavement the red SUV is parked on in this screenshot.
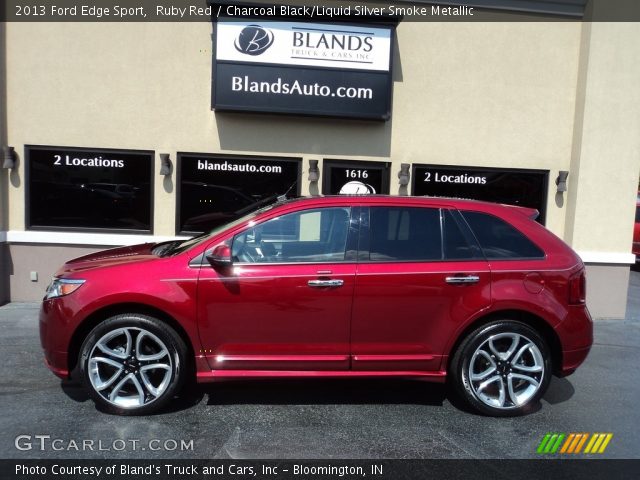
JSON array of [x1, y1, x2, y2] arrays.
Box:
[[0, 272, 640, 459]]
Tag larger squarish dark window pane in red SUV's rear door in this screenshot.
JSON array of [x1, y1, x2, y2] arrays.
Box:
[[369, 207, 442, 262]]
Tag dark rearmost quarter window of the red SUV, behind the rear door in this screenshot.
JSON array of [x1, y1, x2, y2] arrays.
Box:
[[460, 211, 544, 259]]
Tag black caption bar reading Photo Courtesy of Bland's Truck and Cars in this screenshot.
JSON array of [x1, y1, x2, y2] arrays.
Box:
[[0, 459, 640, 480]]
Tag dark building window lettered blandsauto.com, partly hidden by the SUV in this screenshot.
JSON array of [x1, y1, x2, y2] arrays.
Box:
[[178, 153, 300, 232]]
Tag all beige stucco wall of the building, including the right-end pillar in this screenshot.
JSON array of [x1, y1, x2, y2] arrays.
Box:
[[0, 17, 640, 316]]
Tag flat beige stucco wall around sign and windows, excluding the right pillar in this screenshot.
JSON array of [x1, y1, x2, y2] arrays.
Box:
[[7, 22, 581, 235]]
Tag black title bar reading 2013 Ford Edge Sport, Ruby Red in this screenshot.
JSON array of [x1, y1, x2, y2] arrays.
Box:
[[0, 0, 640, 23]]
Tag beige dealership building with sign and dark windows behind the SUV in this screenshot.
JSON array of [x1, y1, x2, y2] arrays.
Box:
[[0, 0, 640, 318]]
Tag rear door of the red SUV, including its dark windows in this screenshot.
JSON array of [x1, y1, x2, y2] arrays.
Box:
[[351, 205, 491, 372]]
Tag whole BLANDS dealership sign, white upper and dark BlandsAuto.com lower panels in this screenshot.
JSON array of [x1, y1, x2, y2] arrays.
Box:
[[212, 17, 393, 120]]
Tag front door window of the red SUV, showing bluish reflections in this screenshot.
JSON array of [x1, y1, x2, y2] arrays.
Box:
[[231, 207, 350, 263]]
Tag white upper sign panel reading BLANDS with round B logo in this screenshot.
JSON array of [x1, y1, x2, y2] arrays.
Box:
[[216, 18, 391, 72]]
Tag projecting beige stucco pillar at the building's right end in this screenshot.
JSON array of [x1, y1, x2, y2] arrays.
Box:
[[566, 23, 640, 253]]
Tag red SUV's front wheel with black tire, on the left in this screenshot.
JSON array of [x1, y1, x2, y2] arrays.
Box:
[[78, 314, 187, 415]]
